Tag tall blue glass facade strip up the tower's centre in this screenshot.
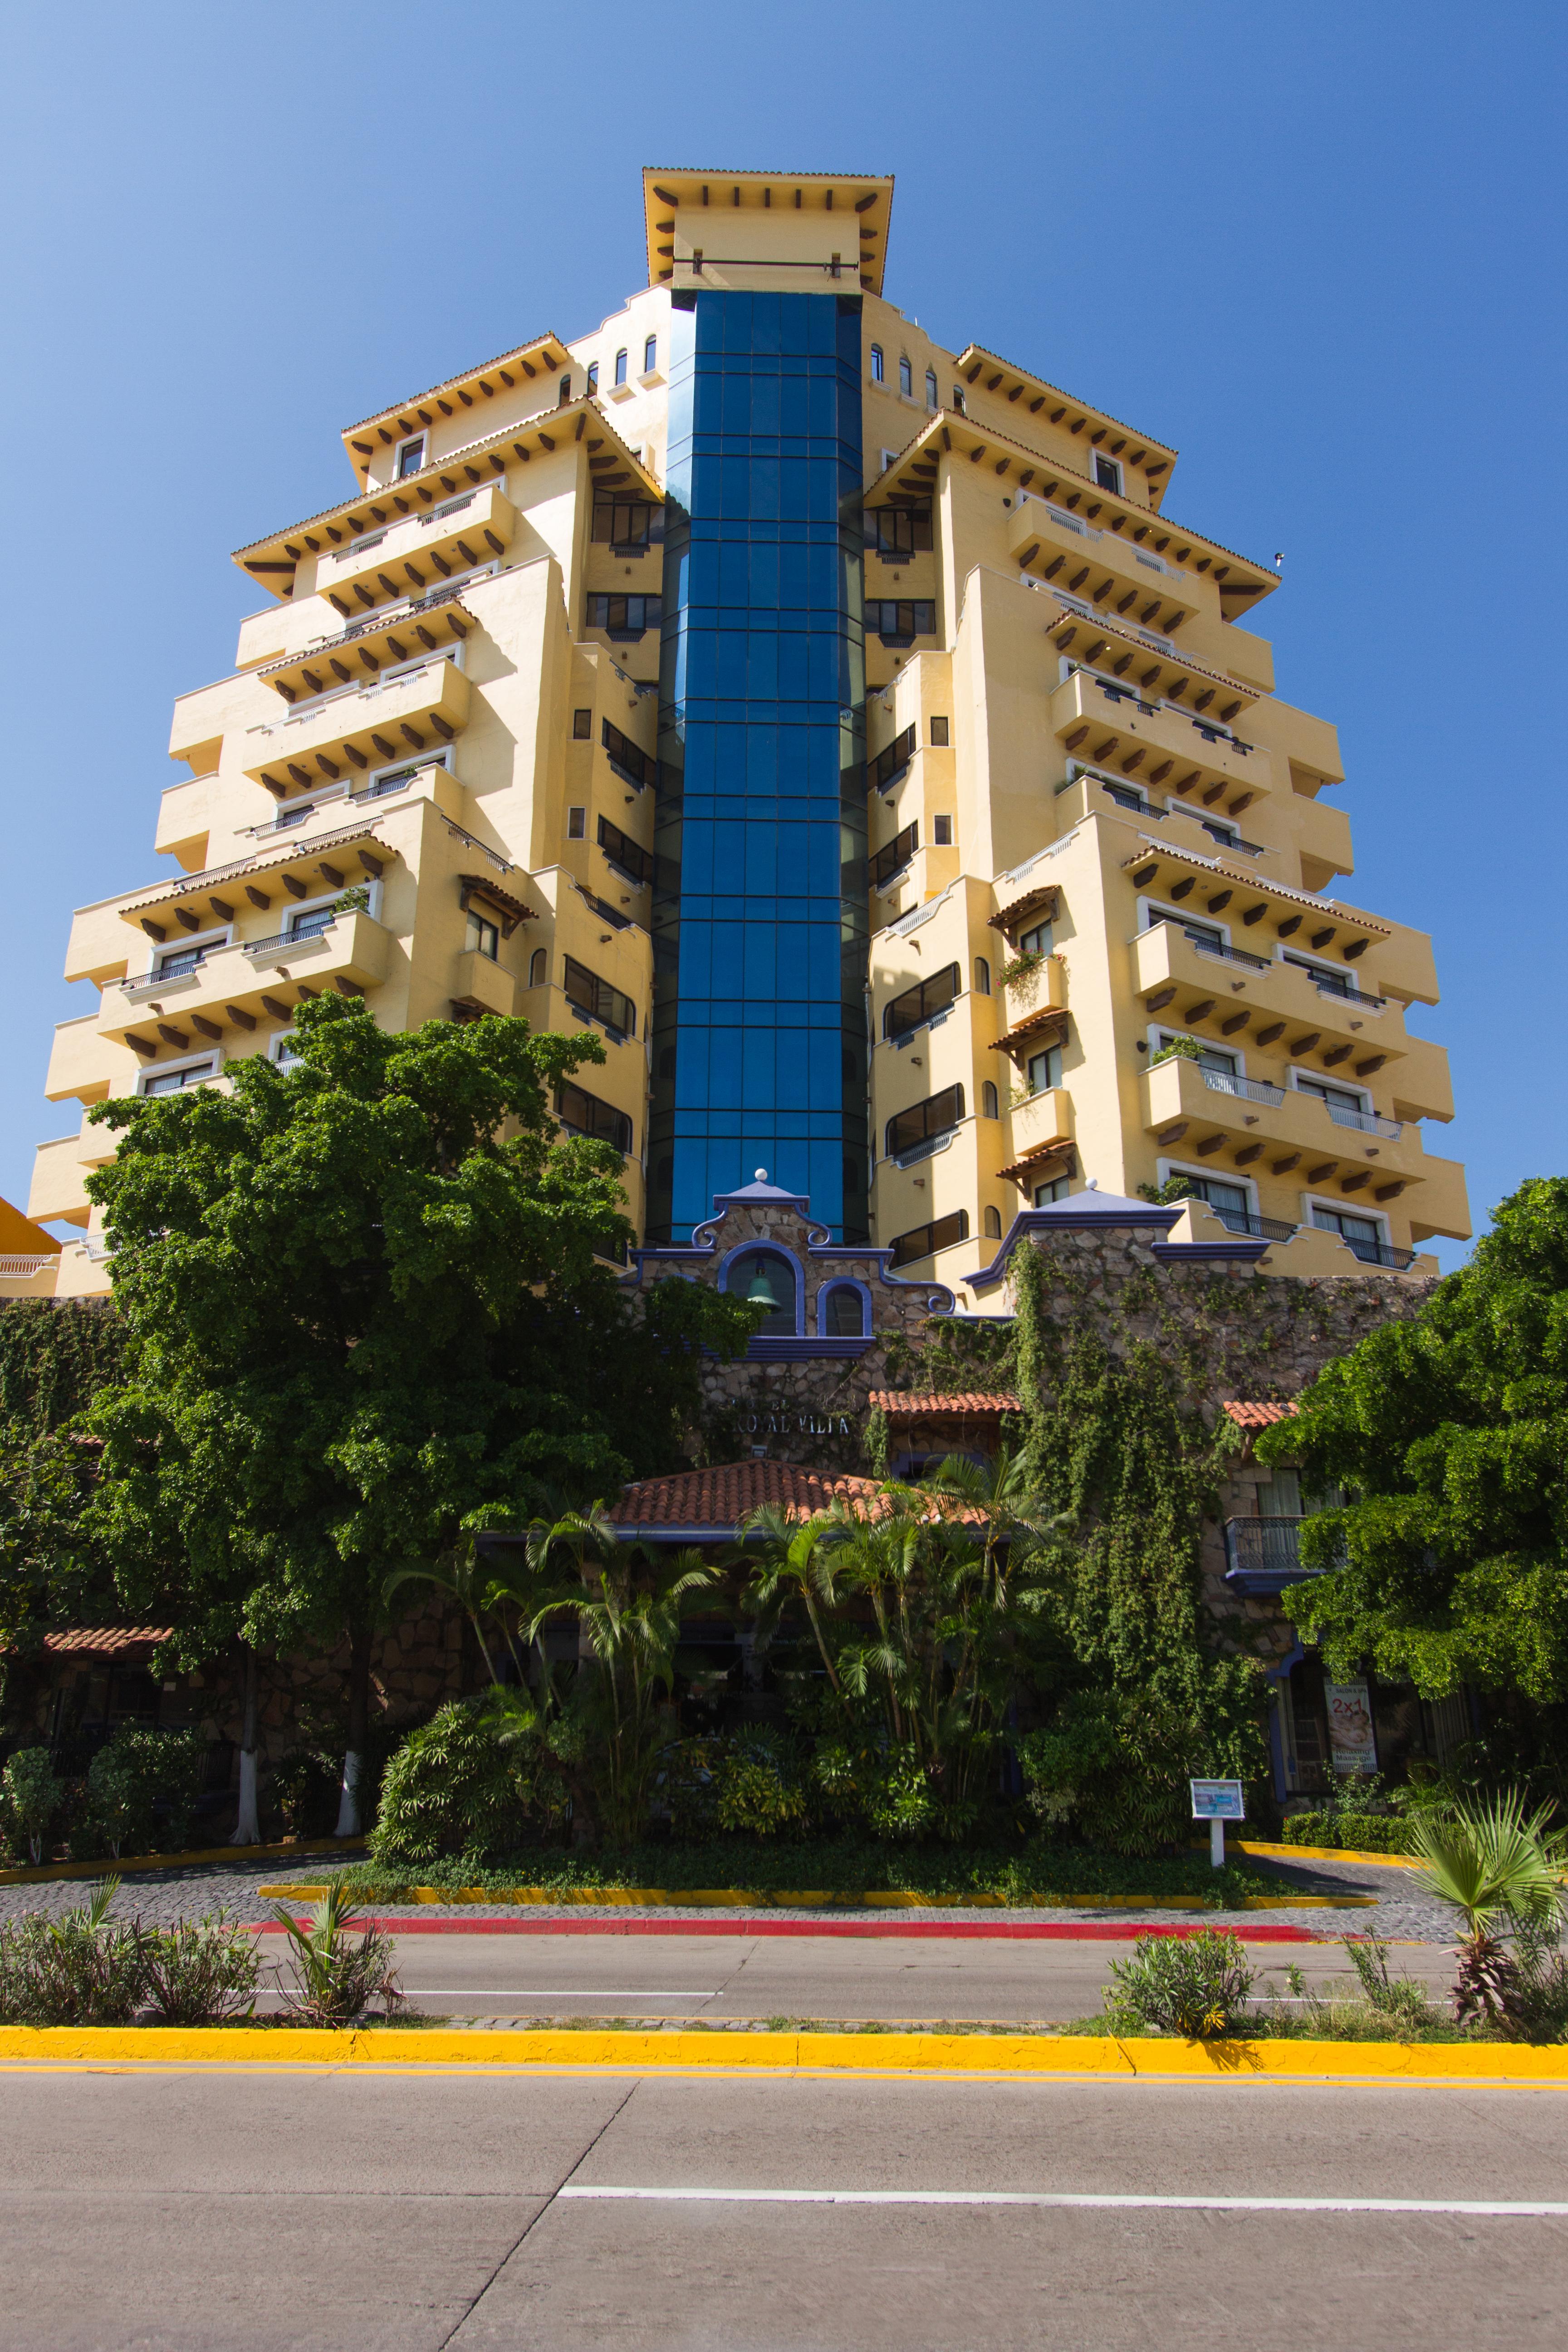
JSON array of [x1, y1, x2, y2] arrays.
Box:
[[649, 289, 870, 1242]]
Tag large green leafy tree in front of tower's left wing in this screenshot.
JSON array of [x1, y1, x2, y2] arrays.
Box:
[[87, 997, 755, 1835]]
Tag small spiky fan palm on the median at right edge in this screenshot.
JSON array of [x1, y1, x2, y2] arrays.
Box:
[[1411, 1790, 1566, 2030]]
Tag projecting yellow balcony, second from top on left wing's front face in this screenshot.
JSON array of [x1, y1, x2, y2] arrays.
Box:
[[242, 647, 468, 800]]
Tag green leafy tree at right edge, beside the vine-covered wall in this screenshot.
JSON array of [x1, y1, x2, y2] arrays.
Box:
[[1258, 1176, 1568, 1703]]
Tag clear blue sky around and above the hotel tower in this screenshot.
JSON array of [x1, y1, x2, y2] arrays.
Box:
[[0, 0, 1568, 1263]]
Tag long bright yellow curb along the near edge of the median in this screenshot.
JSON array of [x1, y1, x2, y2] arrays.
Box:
[[0, 2025, 1568, 2088]]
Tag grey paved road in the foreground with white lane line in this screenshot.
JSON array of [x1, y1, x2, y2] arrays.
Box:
[[0, 2068, 1568, 2352]]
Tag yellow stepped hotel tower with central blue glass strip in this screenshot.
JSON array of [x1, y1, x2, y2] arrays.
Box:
[[28, 169, 1469, 1313]]
